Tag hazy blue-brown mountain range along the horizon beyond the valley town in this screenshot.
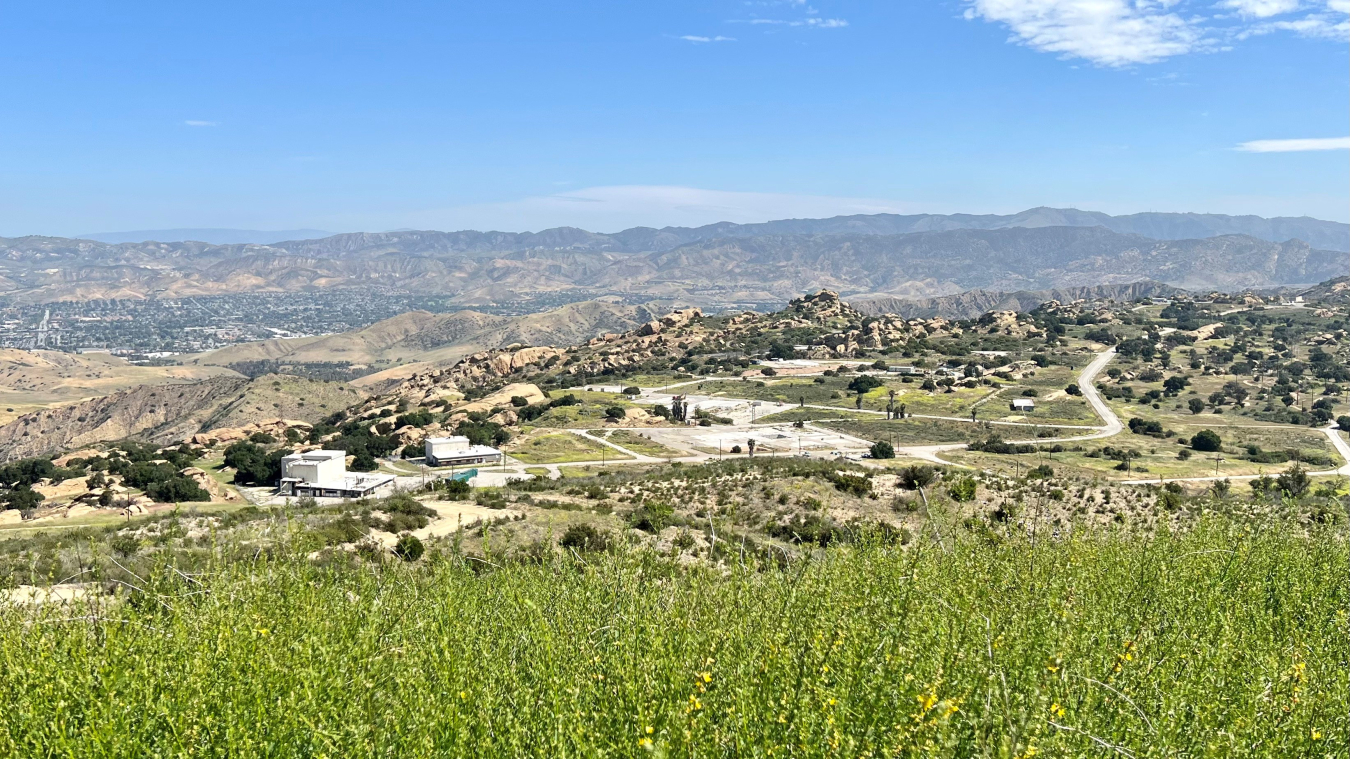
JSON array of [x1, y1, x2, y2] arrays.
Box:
[[0, 208, 1350, 307]]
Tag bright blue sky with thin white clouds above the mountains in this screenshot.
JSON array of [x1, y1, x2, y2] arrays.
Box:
[[0, 0, 1350, 236]]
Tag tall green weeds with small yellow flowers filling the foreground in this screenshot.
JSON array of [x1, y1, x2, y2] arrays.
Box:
[[0, 521, 1350, 758]]
